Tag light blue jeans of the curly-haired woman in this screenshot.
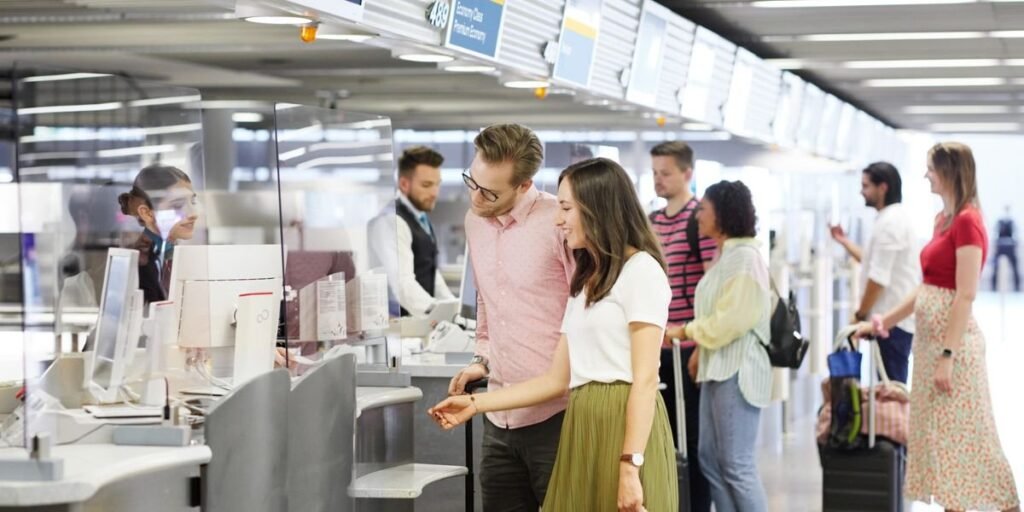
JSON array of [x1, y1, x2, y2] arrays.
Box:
[[698, 374, 768, 512]]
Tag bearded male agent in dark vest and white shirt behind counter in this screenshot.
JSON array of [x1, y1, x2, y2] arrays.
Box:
[[370, 145, 455, 316]]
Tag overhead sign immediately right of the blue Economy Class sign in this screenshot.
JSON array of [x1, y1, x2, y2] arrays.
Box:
[[551, 0, 603, 87]]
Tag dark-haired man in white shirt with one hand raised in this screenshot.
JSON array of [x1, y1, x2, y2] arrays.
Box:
[[831, 162, 921, 382]]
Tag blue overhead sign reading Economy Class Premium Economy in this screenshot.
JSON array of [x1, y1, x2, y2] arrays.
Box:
[[444, 0, 505, 59]]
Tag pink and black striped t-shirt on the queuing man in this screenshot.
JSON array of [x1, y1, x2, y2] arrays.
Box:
[[650, 198, 715, 325]]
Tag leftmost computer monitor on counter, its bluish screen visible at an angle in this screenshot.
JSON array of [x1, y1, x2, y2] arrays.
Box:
[[89, 249, 142, 401]]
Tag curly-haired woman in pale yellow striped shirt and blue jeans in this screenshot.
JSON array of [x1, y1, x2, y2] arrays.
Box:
[[667, 181, 771, 512]]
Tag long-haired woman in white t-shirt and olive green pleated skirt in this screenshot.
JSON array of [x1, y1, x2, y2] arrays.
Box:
[[429, 159, 679, 512]]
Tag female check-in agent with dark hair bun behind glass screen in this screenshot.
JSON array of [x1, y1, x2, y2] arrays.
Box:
[[118, 164, 199, 303]]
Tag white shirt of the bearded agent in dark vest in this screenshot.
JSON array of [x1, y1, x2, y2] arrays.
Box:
[[368, 194, 456, 316]]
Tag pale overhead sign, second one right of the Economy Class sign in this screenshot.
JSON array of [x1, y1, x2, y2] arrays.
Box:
[[626, 0, 675, 106]]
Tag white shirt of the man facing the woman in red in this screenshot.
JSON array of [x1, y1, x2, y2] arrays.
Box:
[[862, 203, 922, 333]]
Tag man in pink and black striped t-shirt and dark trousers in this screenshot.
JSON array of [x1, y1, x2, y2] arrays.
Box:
[[649, 141, 716, 512]]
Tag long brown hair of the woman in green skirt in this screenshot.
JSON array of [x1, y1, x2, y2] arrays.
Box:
[[558, 158, 666, 307]]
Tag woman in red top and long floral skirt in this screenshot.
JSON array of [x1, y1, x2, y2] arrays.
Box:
[[858, 142, 1020, 511]]
